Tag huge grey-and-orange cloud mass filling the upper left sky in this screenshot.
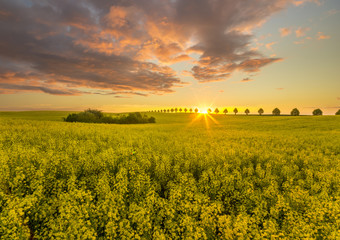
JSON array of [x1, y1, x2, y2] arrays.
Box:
[[0, 0, 291, 96]]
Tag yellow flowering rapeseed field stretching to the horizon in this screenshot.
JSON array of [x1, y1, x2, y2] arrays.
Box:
[[0, 112, 340, 239]]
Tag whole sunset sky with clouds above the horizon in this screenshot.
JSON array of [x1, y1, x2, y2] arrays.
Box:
[[0, 0, 340, 115]]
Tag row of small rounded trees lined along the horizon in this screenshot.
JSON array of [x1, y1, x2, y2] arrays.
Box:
[[149, 108, 340, 116]]
